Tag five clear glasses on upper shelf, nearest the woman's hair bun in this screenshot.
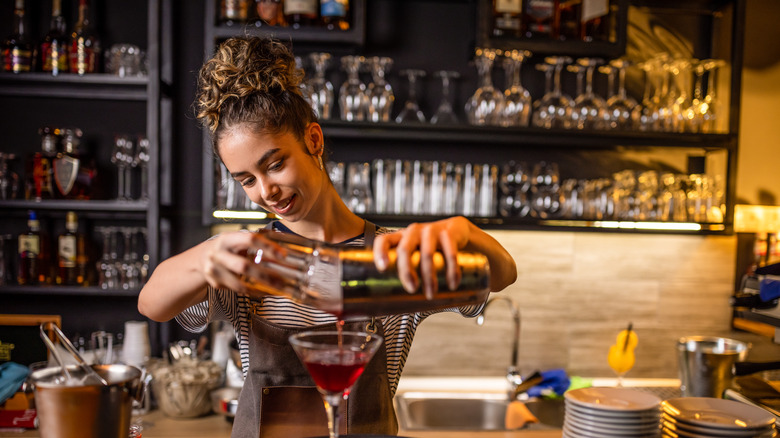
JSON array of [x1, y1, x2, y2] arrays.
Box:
[[298, 53, 460, 124]]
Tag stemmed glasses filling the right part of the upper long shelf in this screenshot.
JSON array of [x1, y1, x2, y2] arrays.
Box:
[[466, 49, 725, 133]]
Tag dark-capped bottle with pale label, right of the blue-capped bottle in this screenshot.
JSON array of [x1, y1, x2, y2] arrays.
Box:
[[57, 211, 89, 286]]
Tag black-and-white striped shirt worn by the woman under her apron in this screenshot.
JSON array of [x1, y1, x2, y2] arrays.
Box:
[[176, 228, 483, 394]]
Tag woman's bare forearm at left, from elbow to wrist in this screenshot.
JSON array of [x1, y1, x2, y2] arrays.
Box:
[[138, 241, 211, 321]]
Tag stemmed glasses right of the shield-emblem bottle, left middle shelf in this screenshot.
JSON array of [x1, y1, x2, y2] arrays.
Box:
[[111, 134, 151, 201]]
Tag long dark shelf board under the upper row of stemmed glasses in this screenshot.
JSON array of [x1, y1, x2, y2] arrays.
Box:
[[321, 120, 737, 150]]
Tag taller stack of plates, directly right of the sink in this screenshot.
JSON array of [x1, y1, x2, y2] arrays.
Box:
[[563, 388, 661, 438]]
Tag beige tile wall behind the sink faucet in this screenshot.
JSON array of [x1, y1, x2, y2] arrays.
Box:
[[404, 231, 736, 377]]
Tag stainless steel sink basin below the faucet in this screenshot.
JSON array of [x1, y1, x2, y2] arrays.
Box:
[[395, 392, 564, 430]]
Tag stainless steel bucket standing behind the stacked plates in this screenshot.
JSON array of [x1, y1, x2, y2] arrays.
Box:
[[677, 336, 750, 398]]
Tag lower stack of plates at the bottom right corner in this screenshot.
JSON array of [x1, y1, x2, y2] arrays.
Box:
[[661, 397, 777, 438]]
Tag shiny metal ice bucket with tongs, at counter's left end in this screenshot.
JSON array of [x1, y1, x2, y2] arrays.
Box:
[[30, 365, 144, 438]]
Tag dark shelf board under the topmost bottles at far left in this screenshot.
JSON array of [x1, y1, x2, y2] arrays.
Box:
[[0, 73, 149, 101]]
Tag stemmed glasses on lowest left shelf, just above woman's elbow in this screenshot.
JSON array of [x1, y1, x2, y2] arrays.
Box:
[[95, 226, 149, 290]]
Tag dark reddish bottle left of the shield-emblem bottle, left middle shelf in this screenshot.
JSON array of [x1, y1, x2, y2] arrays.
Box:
[[25, 126, 60, 201]]
